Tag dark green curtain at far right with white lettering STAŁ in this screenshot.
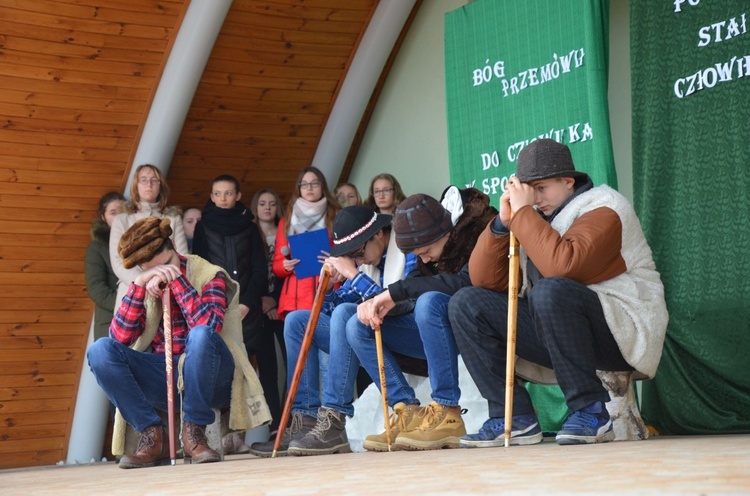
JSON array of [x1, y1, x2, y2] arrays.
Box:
[[630, 0, 750, 434]]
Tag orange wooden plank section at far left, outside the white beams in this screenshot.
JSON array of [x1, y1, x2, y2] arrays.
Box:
[[0, 0, 187, 469]]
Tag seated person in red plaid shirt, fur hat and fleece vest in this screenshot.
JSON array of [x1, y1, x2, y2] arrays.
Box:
[[88, 217, 271, 468]]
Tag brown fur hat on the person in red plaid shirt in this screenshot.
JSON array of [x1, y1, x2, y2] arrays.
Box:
[[117, 217, 172, 269]]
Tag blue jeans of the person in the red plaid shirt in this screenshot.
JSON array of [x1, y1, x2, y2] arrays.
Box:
[[88, 326, 234, 432]]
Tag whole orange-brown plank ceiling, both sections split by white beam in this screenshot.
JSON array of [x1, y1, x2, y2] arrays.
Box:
[[0, 0, 406, 469]]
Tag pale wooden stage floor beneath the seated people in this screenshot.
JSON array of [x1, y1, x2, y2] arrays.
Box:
[[0, 435, 750, 496]]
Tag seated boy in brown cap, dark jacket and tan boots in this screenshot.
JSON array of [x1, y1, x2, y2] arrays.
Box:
[[354, 186, 497, 451]]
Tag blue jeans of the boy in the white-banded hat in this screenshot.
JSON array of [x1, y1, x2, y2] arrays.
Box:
[[284, 303, 359, 417]]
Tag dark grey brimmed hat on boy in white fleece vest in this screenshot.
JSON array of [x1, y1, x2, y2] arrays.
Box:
[[516, 138, 586, 183]]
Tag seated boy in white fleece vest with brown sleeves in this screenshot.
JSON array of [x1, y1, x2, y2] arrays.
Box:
[[449, 139, 668, 447]]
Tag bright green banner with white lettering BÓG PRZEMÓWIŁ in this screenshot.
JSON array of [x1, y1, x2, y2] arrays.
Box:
[[445, 0, 617, 203]]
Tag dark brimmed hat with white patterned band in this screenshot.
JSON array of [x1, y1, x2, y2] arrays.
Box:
[[331, 205, 393, 257]]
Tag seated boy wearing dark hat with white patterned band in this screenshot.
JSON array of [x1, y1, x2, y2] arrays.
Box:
[[250, 205, 416, 456]]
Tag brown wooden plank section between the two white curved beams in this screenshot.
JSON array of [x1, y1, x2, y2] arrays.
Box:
[[168, 0, 378, 208]]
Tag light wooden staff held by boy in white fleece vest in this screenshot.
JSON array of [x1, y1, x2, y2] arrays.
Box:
[[505, 213, 519, 448]]
